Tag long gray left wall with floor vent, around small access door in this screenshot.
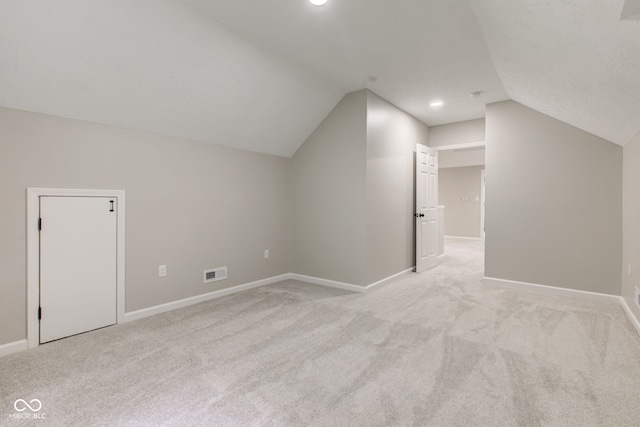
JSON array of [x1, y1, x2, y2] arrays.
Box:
[[0, 109, 291, 345]]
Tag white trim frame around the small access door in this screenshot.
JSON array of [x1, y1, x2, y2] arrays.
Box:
[[26, 187, 125, 349]]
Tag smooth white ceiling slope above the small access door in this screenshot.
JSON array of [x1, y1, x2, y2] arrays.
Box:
[[0, 0, 343, 156]]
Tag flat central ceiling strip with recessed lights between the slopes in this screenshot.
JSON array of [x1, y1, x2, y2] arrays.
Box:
[[182, 0, 508, 126]]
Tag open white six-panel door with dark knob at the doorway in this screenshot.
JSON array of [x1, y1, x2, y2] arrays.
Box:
[[415, 144, 438, 273]]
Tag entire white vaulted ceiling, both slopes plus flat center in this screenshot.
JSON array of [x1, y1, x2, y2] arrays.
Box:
[[0, 0, 640, 157]]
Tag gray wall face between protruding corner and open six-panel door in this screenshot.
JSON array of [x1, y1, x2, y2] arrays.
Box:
[[366, 92, 429, 283]]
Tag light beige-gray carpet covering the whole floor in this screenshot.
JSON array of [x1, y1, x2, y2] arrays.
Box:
[[0, 239, 640, 426]]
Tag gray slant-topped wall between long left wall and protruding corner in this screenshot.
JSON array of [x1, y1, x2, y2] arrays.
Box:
[[291, 90, 367, 285]]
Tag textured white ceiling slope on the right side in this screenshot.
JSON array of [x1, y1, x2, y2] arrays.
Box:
[[473, 0, 640, 145]]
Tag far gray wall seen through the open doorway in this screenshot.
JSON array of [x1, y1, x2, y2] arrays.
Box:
[[438, 166, 484, 237]]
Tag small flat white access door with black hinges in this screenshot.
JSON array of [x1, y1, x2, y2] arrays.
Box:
[[40, 196, 117, 343]]
